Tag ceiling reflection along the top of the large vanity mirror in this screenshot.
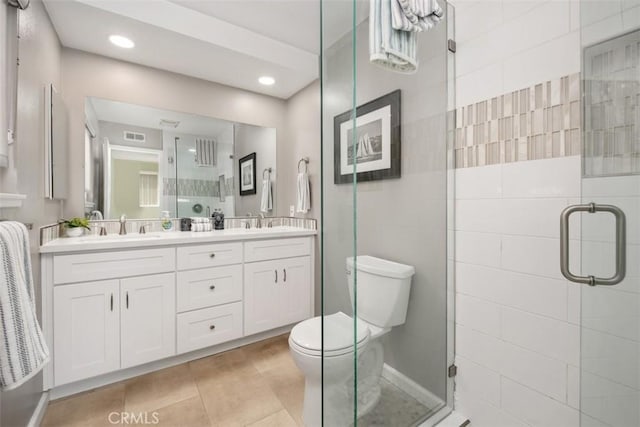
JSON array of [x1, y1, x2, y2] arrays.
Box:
[[88, 98, 232, 137]]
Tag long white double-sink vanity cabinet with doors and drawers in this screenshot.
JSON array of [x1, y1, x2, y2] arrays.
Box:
[[41, 231, 315, 397]]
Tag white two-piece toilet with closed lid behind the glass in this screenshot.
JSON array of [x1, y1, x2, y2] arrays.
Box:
[[289, 256, 415, 427]]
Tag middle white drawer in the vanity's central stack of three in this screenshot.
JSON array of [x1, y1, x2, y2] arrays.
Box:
[[178, 265, 242, 312]]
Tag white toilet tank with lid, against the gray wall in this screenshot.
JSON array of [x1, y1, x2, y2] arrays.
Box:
[[347, 255, 415, 328]]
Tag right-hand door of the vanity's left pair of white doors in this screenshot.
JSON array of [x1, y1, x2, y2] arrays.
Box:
[[120, 273, 176, 369]]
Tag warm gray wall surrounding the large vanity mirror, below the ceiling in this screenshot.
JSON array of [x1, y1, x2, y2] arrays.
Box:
[[62, 48, 288, 219]]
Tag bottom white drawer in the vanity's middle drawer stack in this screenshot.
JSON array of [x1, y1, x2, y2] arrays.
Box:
[[178, 302, 242, 353]]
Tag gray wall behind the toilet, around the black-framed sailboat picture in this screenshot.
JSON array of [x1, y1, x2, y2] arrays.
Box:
[[323, 15, 447, 400]]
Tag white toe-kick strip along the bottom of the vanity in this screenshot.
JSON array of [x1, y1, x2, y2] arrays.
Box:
[[49, 325, 294, 400]]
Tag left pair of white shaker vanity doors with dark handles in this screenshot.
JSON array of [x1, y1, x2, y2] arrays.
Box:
[[53, 273, 176, 385]]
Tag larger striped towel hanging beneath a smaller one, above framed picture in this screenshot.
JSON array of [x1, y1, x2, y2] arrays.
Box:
[[369, 0, 418, 74]]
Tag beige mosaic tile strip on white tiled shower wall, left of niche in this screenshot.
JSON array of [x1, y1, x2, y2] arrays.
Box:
[[454, 73, 581, 168]]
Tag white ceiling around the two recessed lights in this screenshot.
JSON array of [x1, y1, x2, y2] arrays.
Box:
[[44, 0, 367, 99]]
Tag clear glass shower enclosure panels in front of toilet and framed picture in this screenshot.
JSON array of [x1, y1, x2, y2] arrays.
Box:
[[320, 0, 455, 427]]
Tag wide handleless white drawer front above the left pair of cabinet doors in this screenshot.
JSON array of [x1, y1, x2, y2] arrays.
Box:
[[53, 248, 176, 284]]
